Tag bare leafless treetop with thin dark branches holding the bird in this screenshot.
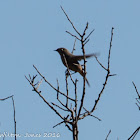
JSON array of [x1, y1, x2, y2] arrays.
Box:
[[25, 7, 115, 140]]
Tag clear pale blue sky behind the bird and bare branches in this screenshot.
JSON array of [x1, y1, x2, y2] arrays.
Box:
[[0, 0, 140, 140]]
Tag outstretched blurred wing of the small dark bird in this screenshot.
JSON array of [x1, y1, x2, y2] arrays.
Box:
[[72, 53, 99, 61]]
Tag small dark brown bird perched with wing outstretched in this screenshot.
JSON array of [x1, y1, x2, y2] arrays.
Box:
[[54, 48, 97, 86]]
